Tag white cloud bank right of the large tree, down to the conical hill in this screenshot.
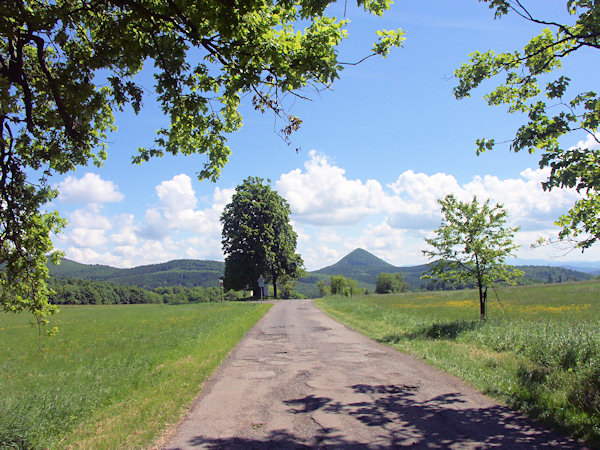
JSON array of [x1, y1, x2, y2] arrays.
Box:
[[276, 151, 579, 269]]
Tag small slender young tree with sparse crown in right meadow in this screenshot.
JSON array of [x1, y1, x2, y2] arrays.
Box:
[[423, 194, 523, 319]]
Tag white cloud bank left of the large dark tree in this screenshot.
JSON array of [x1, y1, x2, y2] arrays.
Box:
[[57, 174, 227, 267]]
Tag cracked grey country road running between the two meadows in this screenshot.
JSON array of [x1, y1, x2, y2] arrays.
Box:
[[165, 300, 580, 449]]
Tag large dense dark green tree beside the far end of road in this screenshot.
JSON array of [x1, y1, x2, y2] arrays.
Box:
[[221, 177, 304, 297]]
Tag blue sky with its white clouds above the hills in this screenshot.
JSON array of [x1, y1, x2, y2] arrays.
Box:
[[51, 0, 600, 270]]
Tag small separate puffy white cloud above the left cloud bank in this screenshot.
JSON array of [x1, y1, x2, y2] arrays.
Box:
[[58, 172, 123, 204]]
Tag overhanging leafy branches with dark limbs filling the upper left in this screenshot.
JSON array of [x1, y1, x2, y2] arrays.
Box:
[[0, 0, 403, 320]]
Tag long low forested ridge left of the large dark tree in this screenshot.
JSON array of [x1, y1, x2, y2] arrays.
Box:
[[48, 259, 224, 289]]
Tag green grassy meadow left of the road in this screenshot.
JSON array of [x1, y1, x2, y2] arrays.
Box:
[[0, 303, 269, 448]]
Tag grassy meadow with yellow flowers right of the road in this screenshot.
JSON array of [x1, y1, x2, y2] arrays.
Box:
[[315, 281, 600, 446]]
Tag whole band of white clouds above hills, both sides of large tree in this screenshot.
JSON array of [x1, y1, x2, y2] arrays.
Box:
[[51, 151, 592, 270]]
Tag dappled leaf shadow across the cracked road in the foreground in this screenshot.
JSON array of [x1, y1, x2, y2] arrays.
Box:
[[177, 384, 585, 449]]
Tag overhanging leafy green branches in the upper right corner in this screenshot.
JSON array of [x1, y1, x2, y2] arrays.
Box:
[[454, 0, 600, 251]]
